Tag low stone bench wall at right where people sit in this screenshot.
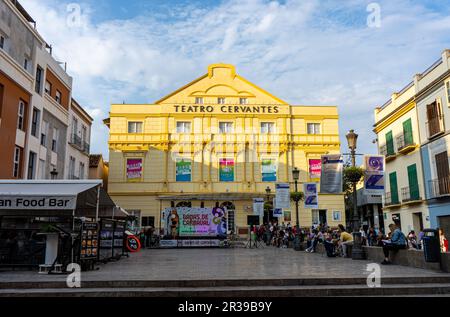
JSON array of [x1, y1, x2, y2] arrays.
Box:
[[363, 246, 450, 272]]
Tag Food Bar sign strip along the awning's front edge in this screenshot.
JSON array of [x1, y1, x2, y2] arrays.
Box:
[[0, 196, 77, 210]]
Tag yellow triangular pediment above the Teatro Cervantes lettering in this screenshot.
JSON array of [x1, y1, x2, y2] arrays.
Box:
[[155, 64, 287, 105]]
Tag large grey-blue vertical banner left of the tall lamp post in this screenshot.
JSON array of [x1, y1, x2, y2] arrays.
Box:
[[320, 154, 344, 194]]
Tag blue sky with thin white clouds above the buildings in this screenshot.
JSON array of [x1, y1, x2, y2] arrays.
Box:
[[21, 0, 450, 157]]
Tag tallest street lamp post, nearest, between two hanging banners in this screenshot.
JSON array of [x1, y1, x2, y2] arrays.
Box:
[[346, 130, 364, 260]]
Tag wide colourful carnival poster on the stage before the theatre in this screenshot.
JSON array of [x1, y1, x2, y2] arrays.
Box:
[[162, 207, 227, 238]]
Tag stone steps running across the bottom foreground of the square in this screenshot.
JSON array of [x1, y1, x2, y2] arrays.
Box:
[[0, 275, 450, 298]]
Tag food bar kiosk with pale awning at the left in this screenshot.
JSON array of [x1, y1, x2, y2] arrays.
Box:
[[0, 180, 127, 268]]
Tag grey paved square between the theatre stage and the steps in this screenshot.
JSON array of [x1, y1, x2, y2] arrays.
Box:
[[0, 247, 450, 282]]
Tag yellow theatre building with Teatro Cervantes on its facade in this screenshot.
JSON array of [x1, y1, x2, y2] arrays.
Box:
[[105, 64, 345, 233]]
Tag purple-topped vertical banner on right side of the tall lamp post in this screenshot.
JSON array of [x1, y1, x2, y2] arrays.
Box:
[[364, 155, 385, 195]]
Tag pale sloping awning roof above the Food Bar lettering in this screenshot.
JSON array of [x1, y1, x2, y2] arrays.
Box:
[[0, 179, 102, 197]]
